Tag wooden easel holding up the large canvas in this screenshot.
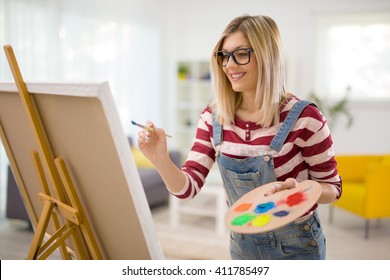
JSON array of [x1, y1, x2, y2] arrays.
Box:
[[2, 45, 103, 259]]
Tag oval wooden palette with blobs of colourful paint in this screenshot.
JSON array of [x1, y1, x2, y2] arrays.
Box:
[[225, 180, 321, 234]]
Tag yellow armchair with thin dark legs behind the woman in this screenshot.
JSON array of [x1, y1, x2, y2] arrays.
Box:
[[330, 155, 390, 238]]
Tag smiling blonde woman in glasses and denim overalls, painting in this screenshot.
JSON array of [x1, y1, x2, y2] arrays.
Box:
[[138, 15, 341, 259]]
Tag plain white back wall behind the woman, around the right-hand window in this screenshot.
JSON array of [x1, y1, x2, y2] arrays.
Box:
[[160, 0, 390, 153]]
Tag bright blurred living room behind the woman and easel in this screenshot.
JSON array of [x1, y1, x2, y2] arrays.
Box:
[[0, 0, 390, 259]]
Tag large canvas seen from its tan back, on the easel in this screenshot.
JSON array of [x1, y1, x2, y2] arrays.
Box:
[[0, 82, 164, 259]]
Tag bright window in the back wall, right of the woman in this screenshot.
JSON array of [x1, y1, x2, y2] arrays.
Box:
[[317, 13, 390, 100]]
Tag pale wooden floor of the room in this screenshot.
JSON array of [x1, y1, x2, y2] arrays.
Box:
[[0, 203, 390, 260]]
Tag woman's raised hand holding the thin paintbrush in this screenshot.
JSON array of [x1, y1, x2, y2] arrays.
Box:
[[137, 121, 169, 168]]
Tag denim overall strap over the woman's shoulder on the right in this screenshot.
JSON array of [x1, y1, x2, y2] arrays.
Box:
[[269, 100, 312, 152]]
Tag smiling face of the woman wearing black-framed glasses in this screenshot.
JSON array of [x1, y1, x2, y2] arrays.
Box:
[[222, 31, 258, 94]]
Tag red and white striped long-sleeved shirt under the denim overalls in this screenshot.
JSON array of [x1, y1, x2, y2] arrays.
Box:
[[173, 98, 341, 199]]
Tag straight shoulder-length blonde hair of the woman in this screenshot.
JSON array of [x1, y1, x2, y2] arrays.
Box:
[[211, 15, 287, 127]]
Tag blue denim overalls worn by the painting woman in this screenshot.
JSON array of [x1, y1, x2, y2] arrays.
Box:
[[213, 101, 325, 260]]
